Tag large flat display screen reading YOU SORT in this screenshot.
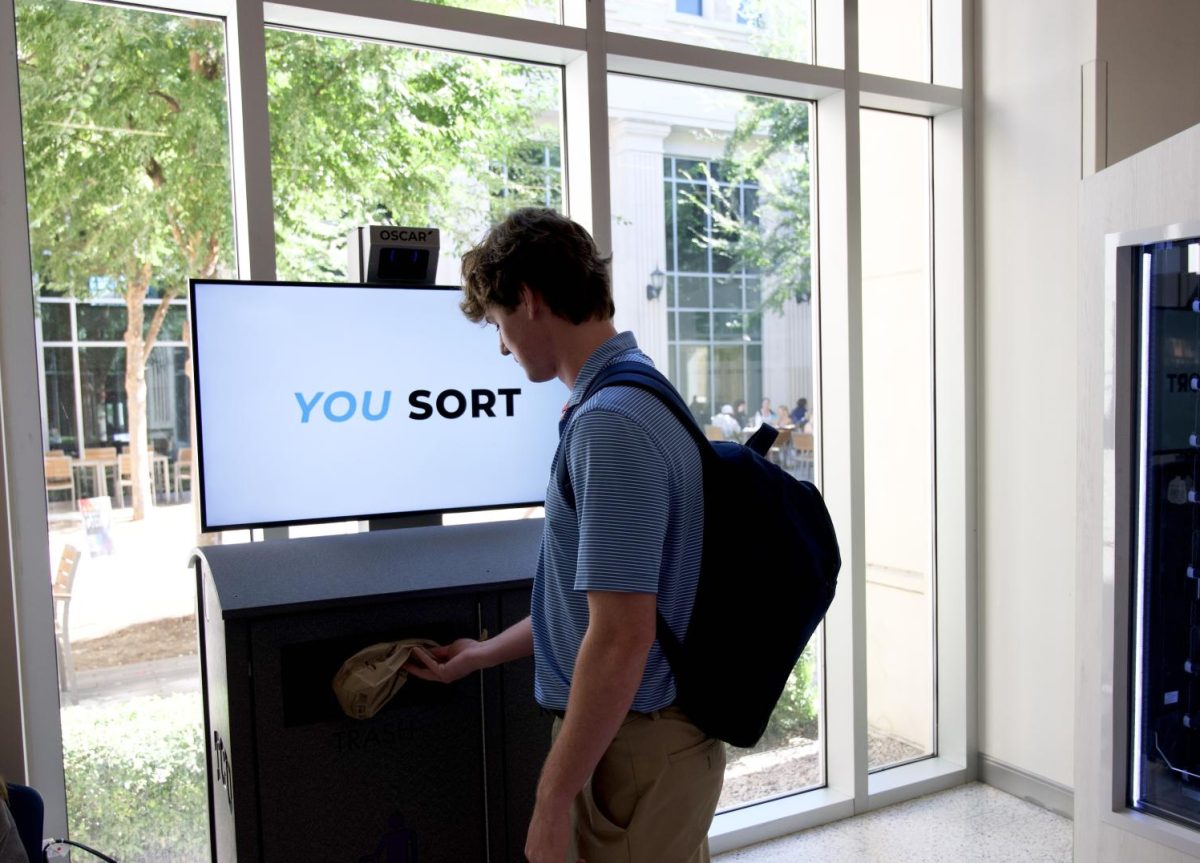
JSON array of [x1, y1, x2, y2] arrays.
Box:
[[191, 280, 569, 531]]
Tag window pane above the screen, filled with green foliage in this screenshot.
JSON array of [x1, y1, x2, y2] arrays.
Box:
[[266, 30, 562, 279]]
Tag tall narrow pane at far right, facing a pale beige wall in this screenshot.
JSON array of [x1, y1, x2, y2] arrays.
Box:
[[862, 110, 936, 768]]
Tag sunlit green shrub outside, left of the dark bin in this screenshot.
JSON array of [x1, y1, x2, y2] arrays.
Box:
[[62, 693, 210, 863]]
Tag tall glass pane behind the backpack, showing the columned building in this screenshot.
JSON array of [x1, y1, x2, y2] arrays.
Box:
[[608, 76, 824, 809]]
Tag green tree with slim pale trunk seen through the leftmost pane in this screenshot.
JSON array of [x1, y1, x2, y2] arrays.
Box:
[[17, 0, 232, 519]]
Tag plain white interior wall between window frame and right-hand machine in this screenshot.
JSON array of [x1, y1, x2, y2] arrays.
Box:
[[976, 0, 1096, 786]]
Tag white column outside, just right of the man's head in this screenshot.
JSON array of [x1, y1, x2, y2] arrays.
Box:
[[608, 120, 671, 372]]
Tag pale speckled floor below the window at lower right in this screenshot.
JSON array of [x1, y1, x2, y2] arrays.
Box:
[[714, 783, 1072, 863]]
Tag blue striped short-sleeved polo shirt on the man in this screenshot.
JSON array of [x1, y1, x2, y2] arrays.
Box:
[[532, 332, 704, 713]]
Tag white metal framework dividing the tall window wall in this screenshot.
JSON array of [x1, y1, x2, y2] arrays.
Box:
[[0, 0, 977, 852]]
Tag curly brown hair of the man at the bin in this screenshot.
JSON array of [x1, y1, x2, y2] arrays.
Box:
[[460, 206, 614, 324]]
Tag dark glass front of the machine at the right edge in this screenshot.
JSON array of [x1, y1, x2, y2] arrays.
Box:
[[1130, 239, 1200, 826]]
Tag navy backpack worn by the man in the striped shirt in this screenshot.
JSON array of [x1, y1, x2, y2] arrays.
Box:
[[563, 361, 841, 747]]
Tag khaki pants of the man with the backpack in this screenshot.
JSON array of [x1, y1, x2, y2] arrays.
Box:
[[552, 707, 725, 863]]
